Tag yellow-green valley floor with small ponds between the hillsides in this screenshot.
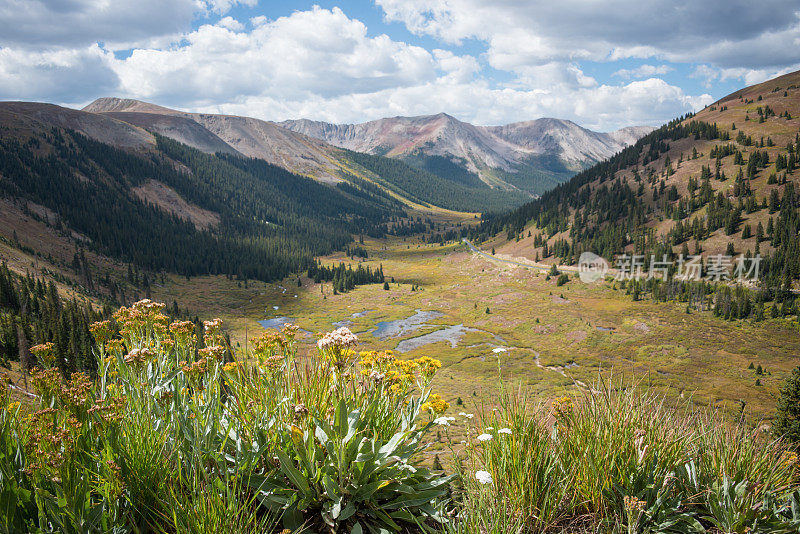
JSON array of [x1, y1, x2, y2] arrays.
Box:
[[153, 239, 800, 424]]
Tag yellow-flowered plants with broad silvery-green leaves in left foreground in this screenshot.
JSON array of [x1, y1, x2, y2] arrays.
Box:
[[0, 301, 449, 534]]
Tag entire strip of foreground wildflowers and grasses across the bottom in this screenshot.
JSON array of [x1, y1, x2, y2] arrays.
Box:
[[0, 301, 800, 534]]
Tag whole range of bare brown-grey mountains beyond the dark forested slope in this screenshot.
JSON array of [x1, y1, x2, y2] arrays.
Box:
[[83, 98, 652, 194]]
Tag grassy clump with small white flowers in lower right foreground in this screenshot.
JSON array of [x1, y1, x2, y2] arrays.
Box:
[[446, 385, 800, 534]]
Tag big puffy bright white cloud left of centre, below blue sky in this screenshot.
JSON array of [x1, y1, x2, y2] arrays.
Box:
[[109, 7, 438, 102]]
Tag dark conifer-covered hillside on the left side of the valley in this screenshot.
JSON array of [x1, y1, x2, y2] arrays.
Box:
[[0, 116, 406, 280]]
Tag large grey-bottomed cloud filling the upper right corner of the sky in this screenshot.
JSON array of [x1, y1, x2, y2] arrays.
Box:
[[375, 0, 800, 70]]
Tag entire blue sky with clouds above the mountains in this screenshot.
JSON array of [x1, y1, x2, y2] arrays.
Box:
[[0, 0, 800, 131]]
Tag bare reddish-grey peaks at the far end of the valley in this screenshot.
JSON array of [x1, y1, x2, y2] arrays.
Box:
[[279, 113, 652, 193]]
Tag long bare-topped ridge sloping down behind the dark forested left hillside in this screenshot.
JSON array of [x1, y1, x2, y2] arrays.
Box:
[[79, 98, 532, 212]]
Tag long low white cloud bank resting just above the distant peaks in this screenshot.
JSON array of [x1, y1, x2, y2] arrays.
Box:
[[198, 72, 714, 131]]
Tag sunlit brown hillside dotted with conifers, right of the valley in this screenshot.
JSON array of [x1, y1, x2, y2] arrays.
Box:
[[476, 68, 800, 306]]
